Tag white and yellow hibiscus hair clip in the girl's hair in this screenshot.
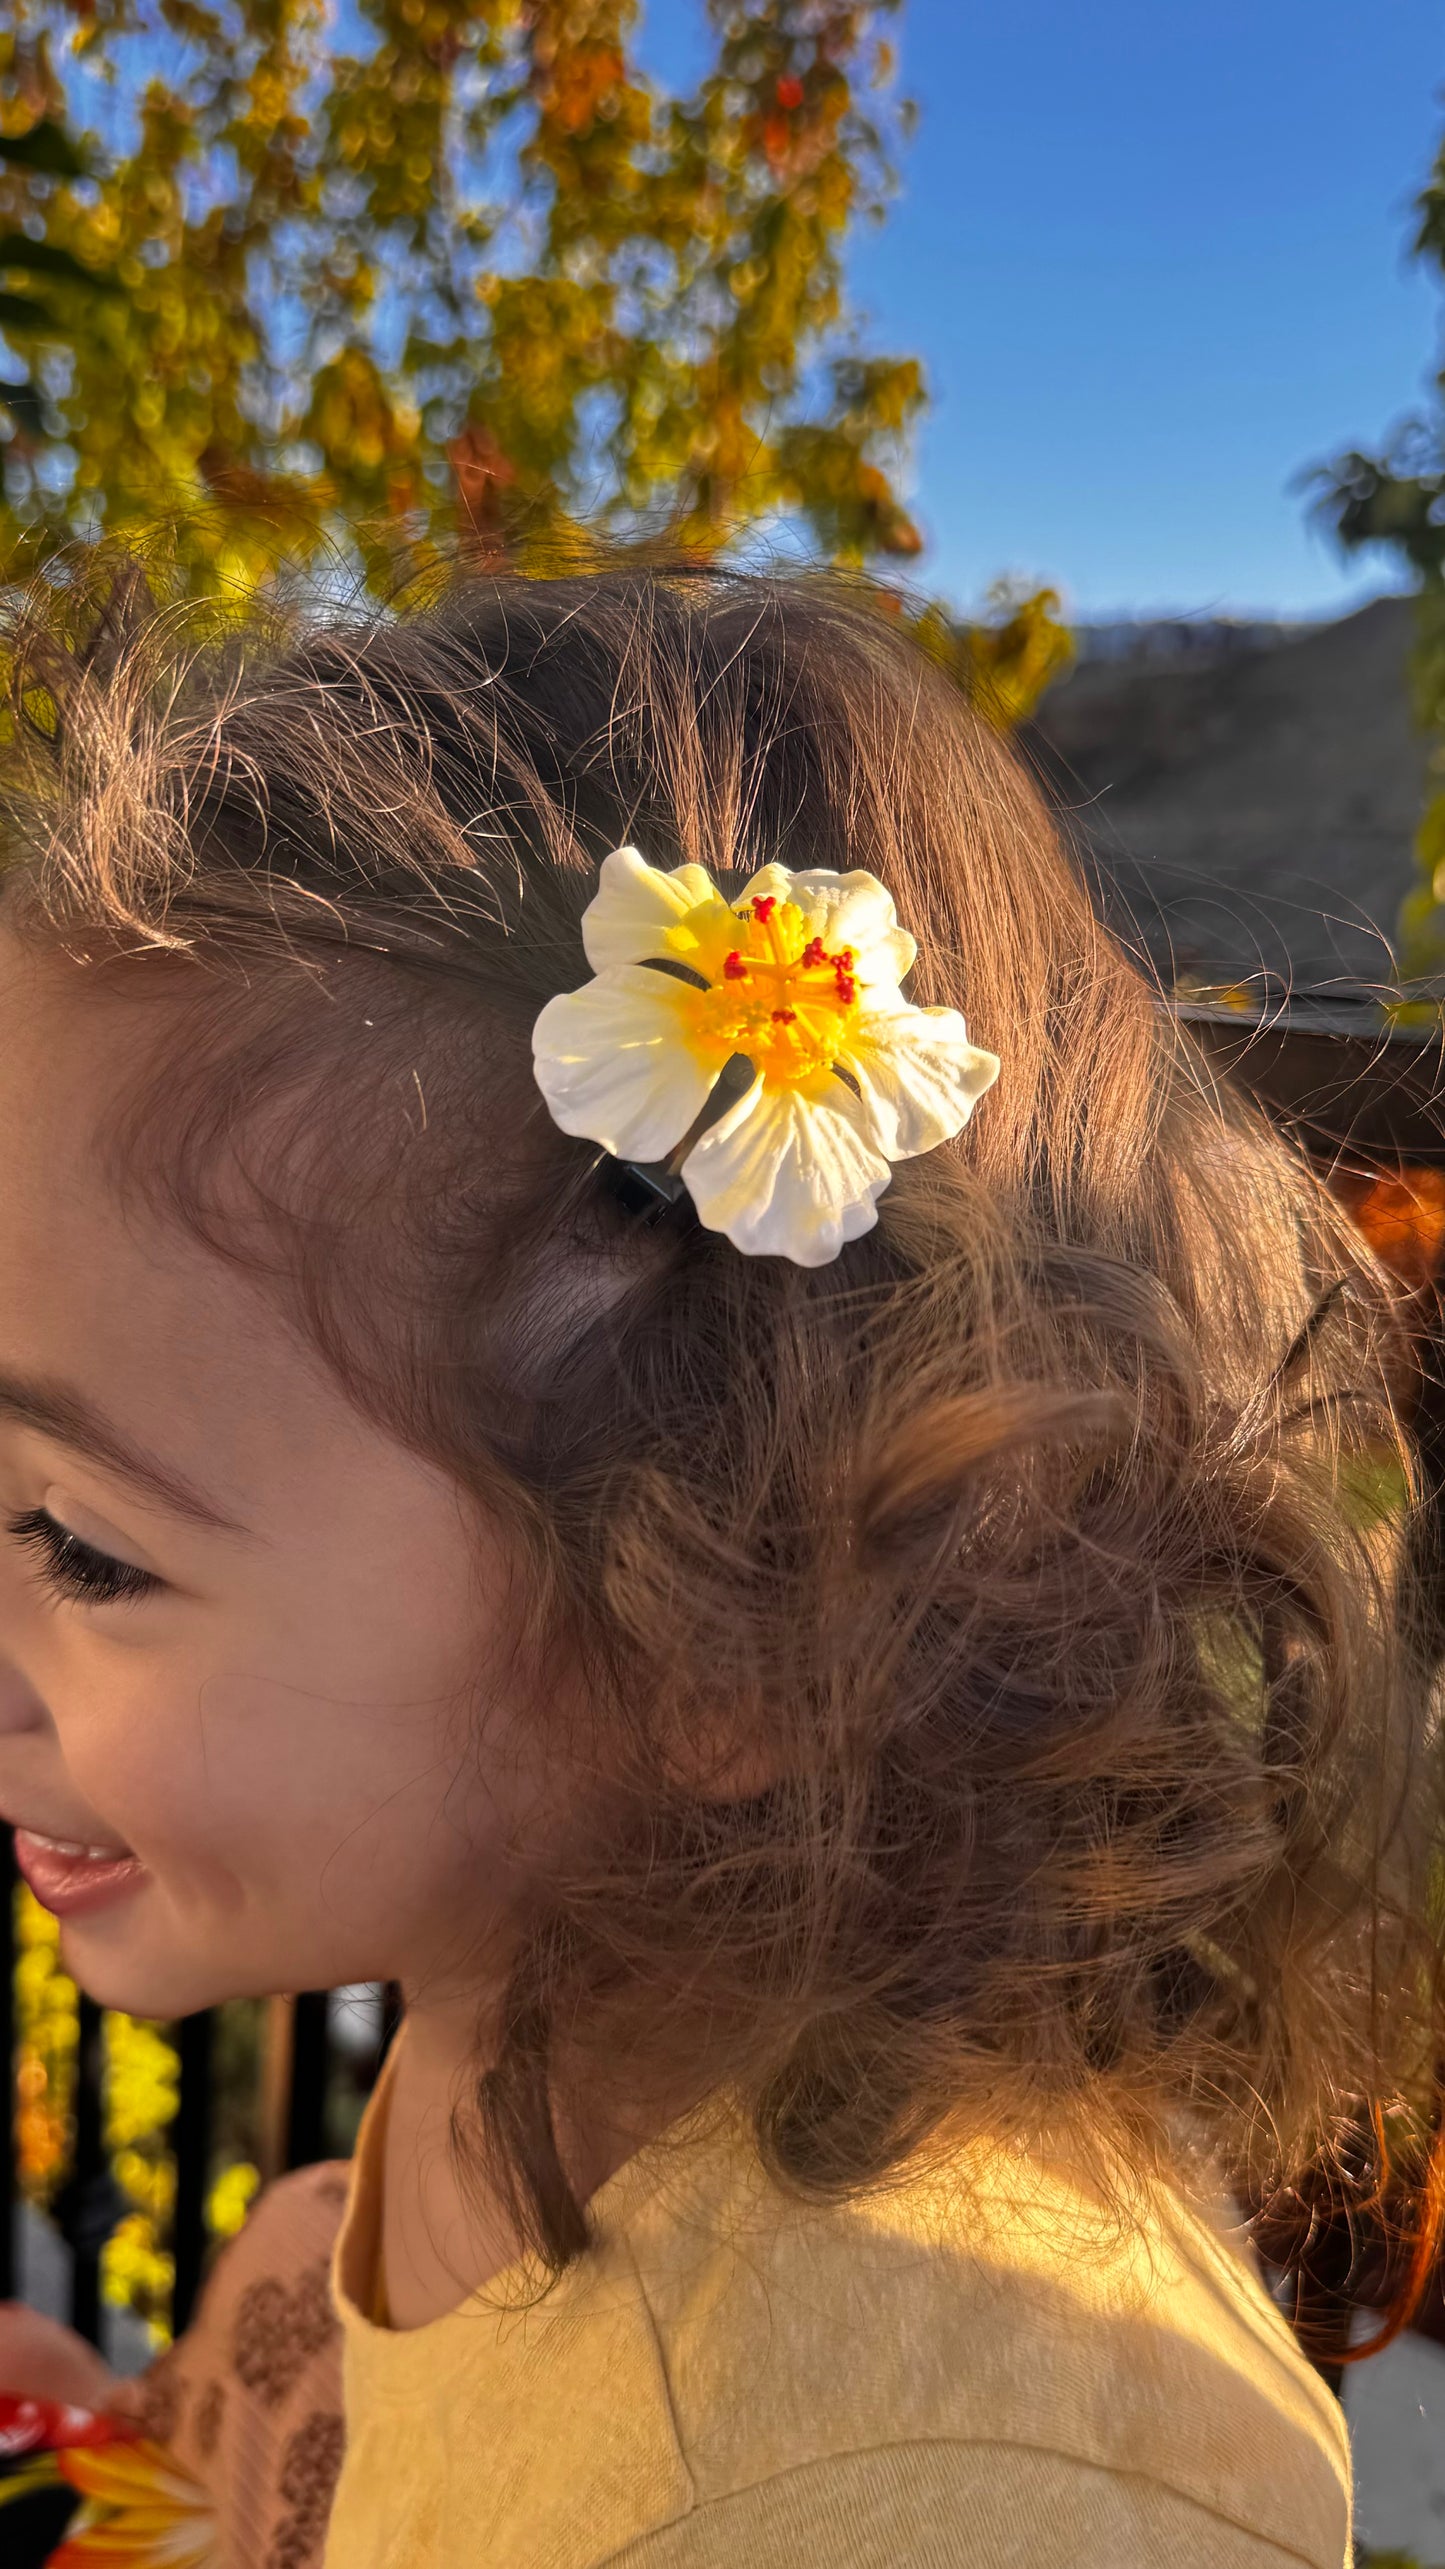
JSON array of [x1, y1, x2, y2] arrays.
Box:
[[521, 848, 998, 1267]]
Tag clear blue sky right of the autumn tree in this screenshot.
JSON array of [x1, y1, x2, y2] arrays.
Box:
[[645, 0, 1445, 617]]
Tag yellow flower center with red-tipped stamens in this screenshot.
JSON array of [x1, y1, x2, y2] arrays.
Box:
[[666, 894, 859, 1087]]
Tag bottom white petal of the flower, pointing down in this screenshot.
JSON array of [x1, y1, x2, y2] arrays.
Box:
[[681, 1074, 892, 1267]]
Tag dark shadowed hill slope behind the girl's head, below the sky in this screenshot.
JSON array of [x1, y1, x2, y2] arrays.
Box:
[[1023, 599, 1424, 984]]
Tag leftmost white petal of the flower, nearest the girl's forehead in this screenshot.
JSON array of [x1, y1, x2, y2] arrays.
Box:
[[532, 963, 717, 1159]]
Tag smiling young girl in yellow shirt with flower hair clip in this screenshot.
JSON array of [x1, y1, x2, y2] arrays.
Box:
[[0, 573, 1435, 2569]]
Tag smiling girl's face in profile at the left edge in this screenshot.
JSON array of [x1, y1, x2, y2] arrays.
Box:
[[0, 935, 547, 2017]]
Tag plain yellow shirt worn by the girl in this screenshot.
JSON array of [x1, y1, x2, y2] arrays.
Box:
[[327, 2044, 1350, 2569]]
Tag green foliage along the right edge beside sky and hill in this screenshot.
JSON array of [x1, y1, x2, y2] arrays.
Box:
[[1314, 105, 1445, 981]]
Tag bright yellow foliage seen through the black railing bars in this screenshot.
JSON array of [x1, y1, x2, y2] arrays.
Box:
[[15, 1886, 260, 2345]]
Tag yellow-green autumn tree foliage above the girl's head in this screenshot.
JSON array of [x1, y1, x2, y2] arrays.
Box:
[[0, 0, 1067, 719]]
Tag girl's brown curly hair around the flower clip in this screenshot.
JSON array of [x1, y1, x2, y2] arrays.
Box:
[[8, 570, 1440, 2332]]
